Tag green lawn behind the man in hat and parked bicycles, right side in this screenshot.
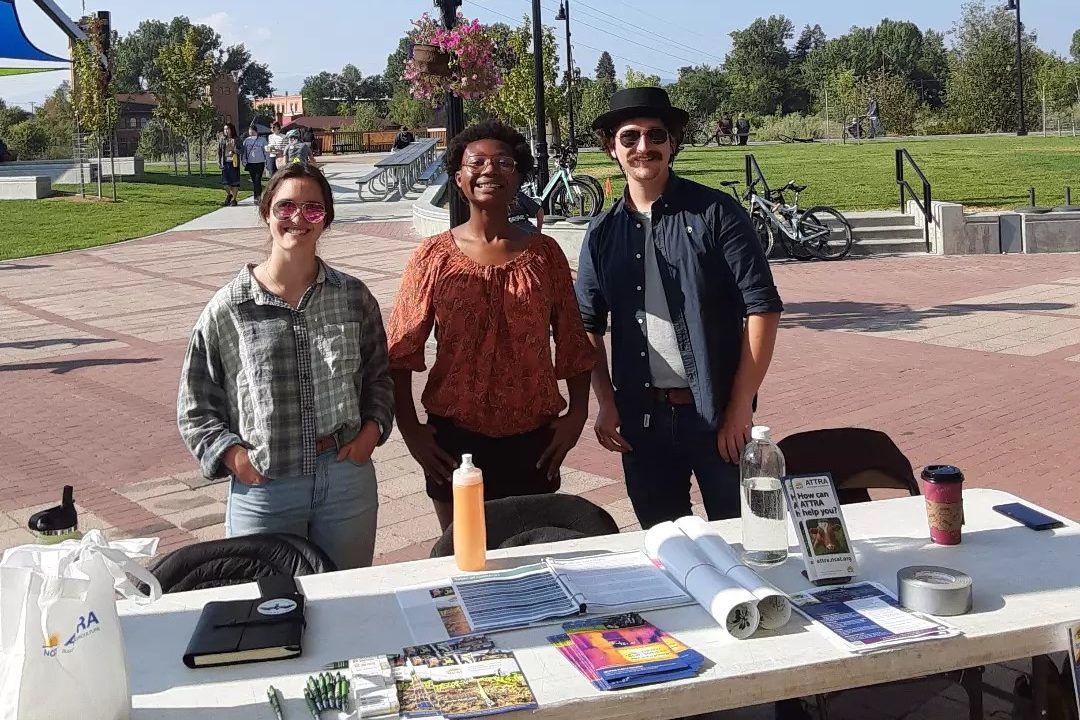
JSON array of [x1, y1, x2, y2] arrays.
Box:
[[578, 136, 1080, 209]]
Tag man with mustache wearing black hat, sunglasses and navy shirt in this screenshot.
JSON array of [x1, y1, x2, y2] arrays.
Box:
[[577, 87, 783, 528]]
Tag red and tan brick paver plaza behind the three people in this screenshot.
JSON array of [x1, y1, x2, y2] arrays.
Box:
[[0, 221, 1080, 562]]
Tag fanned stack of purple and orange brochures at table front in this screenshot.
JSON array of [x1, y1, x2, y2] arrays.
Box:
[[548, 612, 705, 690]]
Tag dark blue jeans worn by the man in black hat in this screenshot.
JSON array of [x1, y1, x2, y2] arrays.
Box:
[[619, 402, 740, 529]]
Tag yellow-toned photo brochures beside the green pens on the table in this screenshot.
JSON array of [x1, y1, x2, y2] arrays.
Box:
[[390, 635, 537, 720]]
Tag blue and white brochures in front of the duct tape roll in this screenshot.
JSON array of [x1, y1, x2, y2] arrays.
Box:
[[791, 582, 960, 654]]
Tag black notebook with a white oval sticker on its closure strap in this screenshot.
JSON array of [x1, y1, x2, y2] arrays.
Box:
[[184, 575, 305, 668]]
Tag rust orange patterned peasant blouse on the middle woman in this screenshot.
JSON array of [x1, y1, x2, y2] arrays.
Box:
[[387, 231, 595, 437]]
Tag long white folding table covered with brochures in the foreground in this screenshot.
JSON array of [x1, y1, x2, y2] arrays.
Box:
[[120, 489, 1080, 720]]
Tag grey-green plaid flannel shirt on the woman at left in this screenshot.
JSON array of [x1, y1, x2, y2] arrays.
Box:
[[176, 261, 394, 479]]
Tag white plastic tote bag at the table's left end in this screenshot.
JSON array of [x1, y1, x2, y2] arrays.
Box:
[[0, 530, 161, 720]]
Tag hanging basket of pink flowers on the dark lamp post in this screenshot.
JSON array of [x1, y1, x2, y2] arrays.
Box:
[[404, 13, 503, 101]]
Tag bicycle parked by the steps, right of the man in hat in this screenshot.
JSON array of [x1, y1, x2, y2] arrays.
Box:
[[746, 180, 854, 260]]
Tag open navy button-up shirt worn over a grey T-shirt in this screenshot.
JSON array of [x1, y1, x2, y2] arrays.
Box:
[[577, 173, 783, 431]]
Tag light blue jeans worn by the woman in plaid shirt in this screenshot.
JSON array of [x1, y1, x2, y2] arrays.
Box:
[[225, 450, 379, 570]]
